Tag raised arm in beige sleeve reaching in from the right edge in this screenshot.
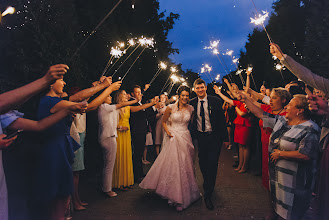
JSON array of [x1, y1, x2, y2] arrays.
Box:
[[270, 43, 329, 96]]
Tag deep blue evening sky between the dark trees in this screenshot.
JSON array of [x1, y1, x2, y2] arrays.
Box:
[[159, 0, 274, 80]]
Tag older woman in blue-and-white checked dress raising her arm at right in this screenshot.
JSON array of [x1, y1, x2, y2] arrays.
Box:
[[240, 92, 320, 219]]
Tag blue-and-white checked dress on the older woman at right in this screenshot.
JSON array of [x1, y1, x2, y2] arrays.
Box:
[[262, 112, 320, 219]]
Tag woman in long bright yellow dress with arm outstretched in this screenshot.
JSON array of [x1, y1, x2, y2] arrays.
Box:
[[113, 90, 159, 190]]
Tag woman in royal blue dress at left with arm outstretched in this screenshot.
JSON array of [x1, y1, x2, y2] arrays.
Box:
[[34, 79, 121, 219]]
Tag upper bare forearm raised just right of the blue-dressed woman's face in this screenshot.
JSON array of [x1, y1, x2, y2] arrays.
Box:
[[70, 77, 112, 102]]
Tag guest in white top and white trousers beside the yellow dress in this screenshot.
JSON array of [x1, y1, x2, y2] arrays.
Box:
[[98, 96, 138, 197]]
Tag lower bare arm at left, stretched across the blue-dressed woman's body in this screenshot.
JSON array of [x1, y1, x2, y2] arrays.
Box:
[[8, 103, 88, 131]]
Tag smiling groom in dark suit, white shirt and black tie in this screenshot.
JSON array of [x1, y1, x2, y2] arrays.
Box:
[[190, 78, 228, 210]]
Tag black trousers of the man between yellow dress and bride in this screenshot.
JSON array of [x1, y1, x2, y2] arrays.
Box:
[[131, 133, 146, 182]]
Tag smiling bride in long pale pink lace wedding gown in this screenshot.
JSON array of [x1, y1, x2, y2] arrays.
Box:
[[139, 86, 200, 211]]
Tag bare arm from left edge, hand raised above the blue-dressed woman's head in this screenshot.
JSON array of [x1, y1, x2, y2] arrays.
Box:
[[0, 64, 69, 114]]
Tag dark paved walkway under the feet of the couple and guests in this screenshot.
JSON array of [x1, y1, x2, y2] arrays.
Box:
[[72, 146, 271, 220]]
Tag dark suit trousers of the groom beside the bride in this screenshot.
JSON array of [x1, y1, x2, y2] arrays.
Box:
[[197, 132, 222, 198]]
